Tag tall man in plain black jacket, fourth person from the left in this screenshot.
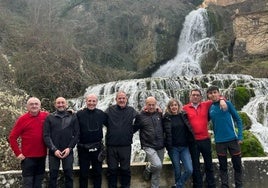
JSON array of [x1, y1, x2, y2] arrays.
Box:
[[106, 91, 137, 188]]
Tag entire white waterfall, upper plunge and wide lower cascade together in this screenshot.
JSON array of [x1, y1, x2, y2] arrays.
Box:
[[69, 9, 268, 162]]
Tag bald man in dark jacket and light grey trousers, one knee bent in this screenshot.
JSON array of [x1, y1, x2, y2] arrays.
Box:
[[134, 96, 168, 188]]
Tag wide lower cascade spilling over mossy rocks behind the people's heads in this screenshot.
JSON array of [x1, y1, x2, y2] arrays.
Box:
[[69, 74, 268, 162]]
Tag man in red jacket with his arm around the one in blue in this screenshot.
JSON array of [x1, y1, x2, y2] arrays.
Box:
[[183, 89, 227, 188]]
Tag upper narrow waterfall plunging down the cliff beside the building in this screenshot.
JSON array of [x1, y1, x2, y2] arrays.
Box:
[[152, 8, 217, 77]]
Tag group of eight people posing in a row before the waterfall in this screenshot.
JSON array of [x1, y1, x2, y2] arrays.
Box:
[[9, 86, 242, 188]]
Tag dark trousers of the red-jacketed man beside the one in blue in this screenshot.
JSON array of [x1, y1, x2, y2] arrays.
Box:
[[190, 138, 216, 188]]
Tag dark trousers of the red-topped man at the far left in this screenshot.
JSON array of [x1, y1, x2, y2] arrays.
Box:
[[21, 156, 46, 188]]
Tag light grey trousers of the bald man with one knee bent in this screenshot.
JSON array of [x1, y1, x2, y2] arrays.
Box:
[[143, 147, 164, 188]]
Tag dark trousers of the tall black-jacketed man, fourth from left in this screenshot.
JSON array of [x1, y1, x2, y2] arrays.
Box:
[[107, 146, 131, 188]]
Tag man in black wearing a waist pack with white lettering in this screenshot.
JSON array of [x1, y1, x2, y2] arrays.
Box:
[[76, 94, 107, 188]]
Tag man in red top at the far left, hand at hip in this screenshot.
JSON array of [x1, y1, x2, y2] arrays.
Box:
[[9, 97, 48, 188]]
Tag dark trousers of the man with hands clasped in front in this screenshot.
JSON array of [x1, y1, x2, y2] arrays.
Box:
[[48, 152, 74, 188]]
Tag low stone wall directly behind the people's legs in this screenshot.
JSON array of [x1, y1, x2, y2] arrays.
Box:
[[0, 157, 268, 188]]
